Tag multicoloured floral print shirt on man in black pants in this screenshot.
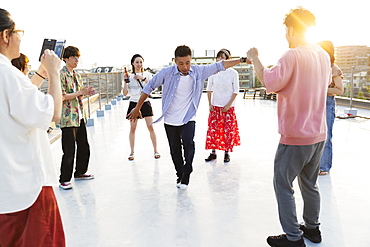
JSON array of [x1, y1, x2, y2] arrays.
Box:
[[57, 66, 84, 128]]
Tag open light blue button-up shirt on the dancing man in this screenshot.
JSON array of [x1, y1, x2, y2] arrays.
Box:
[[143, 61, 225, 124]]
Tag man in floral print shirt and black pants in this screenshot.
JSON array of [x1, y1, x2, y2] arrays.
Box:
[[57, 46, 95, 190]]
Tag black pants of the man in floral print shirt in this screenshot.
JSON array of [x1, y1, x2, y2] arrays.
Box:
[[59, 119, 90, 183]]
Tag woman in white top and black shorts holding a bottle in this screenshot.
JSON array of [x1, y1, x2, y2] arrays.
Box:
[[123, 54, 161, 160]]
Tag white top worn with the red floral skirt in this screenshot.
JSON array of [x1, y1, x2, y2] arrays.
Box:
[[207, 68, 239, 107]]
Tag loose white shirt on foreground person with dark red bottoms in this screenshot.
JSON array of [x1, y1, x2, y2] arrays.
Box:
[[0, 54, 58, 214]]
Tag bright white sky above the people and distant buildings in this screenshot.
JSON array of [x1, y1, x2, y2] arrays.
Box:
[[0, 0, 370, 69]]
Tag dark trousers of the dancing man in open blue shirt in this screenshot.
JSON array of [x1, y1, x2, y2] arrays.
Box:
[[164, 121, 195, 178]]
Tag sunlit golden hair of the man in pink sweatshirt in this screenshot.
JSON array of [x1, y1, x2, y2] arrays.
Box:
[[284, 7, 316, 36]]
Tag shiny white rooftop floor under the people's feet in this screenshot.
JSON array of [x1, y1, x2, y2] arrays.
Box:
[[51, 94, 370, 247]]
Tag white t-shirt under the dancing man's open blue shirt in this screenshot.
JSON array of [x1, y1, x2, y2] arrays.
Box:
[[164, 75, 195, 126]]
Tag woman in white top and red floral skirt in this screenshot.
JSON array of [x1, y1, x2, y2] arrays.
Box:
[[206, 49, 240, 162]]
